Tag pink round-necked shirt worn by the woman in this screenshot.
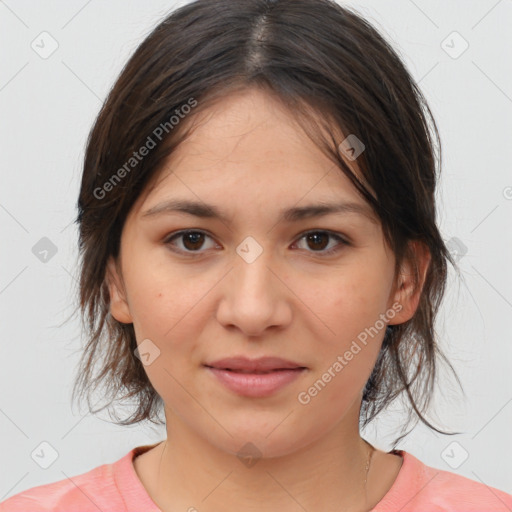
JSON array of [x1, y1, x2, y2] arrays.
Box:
[[0, 445, 512, 512]]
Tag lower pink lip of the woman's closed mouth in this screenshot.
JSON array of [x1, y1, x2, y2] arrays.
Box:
[[207, 366, 306, 398]]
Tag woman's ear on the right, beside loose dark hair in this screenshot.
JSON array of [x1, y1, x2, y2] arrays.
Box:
[[389, 240, 431, 325]]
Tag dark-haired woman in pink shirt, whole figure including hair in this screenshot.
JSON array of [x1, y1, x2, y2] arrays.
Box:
[[1, 0, 512, 512]]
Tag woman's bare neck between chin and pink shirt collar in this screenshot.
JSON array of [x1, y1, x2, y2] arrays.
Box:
[[151, 404, 372, 512]]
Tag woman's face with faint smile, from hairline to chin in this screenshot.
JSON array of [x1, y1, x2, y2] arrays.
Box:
[[109, 90, 415, 457]]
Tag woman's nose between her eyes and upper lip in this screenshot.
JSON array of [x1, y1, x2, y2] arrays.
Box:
[[213, 242, 292, 337]]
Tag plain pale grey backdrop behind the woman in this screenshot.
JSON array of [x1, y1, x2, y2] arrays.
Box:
[[0, 0, 512, 501]]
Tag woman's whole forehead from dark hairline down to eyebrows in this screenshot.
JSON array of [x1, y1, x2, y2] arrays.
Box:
[[130, 90, 365, 220]]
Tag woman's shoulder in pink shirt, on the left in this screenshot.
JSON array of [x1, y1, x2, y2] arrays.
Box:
[[0, 450, 133, 512]]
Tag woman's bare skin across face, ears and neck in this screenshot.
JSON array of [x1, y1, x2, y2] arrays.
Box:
[[108, 90, 429, 512]]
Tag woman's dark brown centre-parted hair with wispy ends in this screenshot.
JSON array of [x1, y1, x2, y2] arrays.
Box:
[[73, 0, 460, 445]]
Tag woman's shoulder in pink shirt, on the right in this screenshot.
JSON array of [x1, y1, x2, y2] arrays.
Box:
[[373, 450, 512, 512]]
